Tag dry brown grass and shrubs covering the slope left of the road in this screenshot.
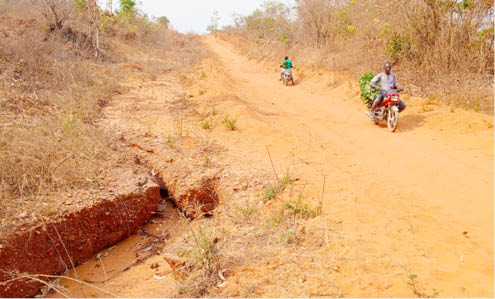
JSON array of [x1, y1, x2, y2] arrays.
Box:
[[0, 0, 204, 230]]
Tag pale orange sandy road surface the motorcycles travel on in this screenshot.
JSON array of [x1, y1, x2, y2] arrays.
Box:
[[200, 38, 493, 296]]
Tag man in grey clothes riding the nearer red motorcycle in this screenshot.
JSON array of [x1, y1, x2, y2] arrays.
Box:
[[367, 61, 406, 117]]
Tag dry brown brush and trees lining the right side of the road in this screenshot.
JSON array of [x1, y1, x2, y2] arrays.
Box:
[[224, 0, 494, 111]]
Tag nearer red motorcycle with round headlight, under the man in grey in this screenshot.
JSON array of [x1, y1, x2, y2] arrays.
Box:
[[368, 89, 402, 132]]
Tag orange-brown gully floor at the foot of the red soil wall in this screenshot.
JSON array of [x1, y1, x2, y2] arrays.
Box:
[[42, 200, 186, 298]]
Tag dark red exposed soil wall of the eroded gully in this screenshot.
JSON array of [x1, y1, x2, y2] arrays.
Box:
[[0, 180, 160, 297]]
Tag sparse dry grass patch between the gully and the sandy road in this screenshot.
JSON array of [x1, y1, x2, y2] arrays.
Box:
[[167, 186, 325, 297]]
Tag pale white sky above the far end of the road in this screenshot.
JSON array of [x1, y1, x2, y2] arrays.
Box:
[[105, 0, 274, 33]]
